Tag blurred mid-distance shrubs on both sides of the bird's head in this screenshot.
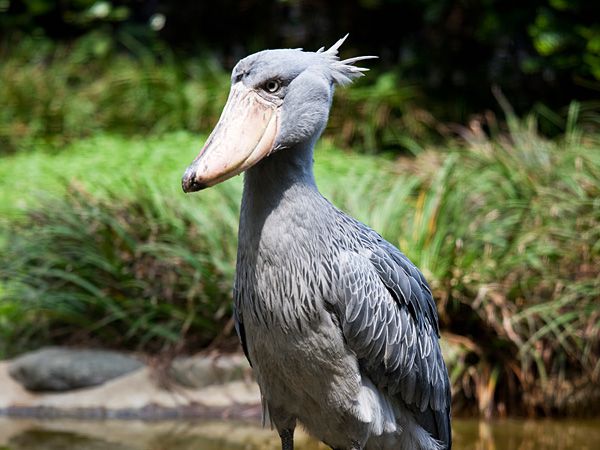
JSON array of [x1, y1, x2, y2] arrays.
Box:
[[0, 33, 439, 154]]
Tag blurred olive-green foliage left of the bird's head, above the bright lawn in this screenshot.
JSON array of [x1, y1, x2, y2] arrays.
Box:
[[0, 33, 229, 154]]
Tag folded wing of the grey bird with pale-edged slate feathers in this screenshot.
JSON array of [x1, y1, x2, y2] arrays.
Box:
[[333, 248, 450, 443]]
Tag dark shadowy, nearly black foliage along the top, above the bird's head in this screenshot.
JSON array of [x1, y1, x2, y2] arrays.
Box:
[[0, 0, 600, 122]]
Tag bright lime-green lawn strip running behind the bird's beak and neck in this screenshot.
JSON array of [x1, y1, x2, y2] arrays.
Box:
[[0, 131, 384, 217]]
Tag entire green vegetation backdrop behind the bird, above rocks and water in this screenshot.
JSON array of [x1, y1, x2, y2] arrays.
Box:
[[0, 0, 600, 417]]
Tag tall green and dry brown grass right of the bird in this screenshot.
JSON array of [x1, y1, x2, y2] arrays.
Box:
[[346, 104, 600, 416]]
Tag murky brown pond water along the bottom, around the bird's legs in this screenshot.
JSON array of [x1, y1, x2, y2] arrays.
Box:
[[0, 418, 600, 450]]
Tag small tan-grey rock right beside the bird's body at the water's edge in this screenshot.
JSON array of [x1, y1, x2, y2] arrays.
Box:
[[169, 355, 251, 389]]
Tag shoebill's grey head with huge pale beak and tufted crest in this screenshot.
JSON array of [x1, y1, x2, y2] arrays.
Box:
[[182, 35, 374, 192]]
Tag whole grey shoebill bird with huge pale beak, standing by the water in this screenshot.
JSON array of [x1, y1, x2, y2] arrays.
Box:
[[182, 38, 452, 450]]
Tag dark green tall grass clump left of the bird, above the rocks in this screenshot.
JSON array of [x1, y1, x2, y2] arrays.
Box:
[[2, 183, 239, 351]]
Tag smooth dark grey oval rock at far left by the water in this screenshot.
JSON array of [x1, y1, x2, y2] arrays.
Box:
[[8, 347, 143, 391]]
